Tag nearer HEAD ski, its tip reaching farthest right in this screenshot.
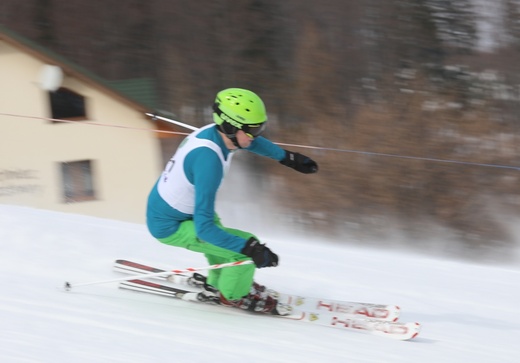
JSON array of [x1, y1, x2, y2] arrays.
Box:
[[119, 279, 421, 340]]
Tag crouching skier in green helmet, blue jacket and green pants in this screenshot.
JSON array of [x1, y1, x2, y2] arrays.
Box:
[[146, 88, 318, 314]]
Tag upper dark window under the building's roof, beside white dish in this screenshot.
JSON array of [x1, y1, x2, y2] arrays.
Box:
[[49, 88, 87, 120]]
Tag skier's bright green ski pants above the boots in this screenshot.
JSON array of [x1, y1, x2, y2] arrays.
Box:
[[158, 216, 256, 300]]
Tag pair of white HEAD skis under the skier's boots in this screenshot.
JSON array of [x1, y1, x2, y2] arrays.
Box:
[[114, 260, 421, 340]]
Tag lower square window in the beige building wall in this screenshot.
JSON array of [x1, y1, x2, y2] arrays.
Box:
[[61, 160, 96, 203]]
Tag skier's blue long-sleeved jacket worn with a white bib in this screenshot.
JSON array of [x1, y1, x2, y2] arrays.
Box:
[[146, 125, 285, 252]]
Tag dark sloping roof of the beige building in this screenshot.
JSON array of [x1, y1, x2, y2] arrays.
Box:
[[0, 24, 157, 113]]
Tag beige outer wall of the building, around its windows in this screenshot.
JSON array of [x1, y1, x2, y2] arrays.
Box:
[[0, 41, 162, 223]]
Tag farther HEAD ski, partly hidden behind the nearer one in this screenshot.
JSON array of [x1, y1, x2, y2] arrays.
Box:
[[114, 260, 401, 322]]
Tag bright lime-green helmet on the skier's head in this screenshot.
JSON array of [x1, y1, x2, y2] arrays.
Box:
[[213, 88, 267, 140]]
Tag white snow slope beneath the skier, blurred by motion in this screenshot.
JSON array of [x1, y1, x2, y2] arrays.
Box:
[[0, 205, 520, 363]]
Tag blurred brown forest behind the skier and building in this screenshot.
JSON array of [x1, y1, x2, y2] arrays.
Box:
[[0, 0, 520, 259]]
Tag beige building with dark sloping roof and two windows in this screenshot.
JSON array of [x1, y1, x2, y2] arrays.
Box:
[[0, 26, 177, 223]]
